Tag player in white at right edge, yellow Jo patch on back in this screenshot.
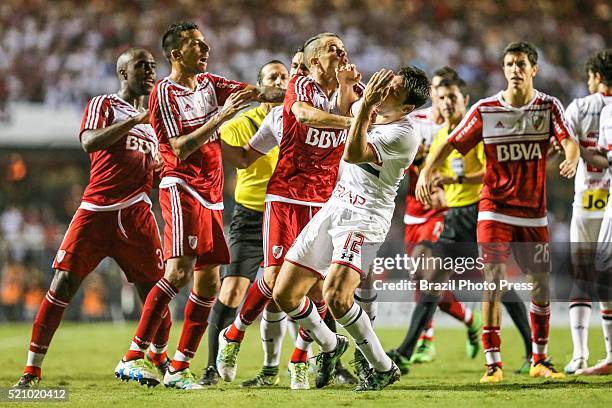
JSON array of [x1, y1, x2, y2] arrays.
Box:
[[564, 50, 612, 374]]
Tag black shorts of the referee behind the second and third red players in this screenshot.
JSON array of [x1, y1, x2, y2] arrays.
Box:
[[221, 204, 263, 282]]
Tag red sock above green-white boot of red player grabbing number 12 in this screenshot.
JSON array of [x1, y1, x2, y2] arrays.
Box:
[[225, 278, 272, 342]]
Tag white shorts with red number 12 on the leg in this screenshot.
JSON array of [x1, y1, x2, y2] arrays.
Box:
[[285, 202, 389, 279]]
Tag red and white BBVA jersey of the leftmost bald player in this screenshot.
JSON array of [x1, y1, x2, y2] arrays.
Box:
[[79, 94, 157, 211]]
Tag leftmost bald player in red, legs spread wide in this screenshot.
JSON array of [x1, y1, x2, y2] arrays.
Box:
[[15, 48, 171, 388]]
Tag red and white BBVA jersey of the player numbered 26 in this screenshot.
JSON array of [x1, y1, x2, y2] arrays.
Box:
[[448, 90, 573, 227]]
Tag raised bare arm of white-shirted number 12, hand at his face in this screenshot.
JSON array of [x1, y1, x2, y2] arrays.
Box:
[[342, 69, 393, 163]]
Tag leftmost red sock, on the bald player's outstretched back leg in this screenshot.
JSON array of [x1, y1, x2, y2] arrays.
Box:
[[23, 290, 69, 378]]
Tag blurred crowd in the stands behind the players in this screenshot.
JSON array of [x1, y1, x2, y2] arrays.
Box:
[[0, 0, 612, 320]]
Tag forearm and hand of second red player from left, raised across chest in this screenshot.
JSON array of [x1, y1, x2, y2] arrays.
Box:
[[169, 89, 253, 160]]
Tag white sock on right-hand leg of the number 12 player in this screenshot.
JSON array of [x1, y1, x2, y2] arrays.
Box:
[[337, 303, 393, 371]]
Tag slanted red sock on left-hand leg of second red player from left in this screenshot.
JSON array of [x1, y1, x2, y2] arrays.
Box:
[[123, 278, 178, 361]]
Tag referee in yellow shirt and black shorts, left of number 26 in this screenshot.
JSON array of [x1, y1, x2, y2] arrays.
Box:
[[430, 78, 531, 374]]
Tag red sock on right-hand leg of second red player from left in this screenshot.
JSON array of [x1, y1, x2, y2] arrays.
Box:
[[172, 292, 215, 371]]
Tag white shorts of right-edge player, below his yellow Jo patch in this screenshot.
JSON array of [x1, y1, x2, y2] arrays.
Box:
[[570, 214, 602, 265]]
